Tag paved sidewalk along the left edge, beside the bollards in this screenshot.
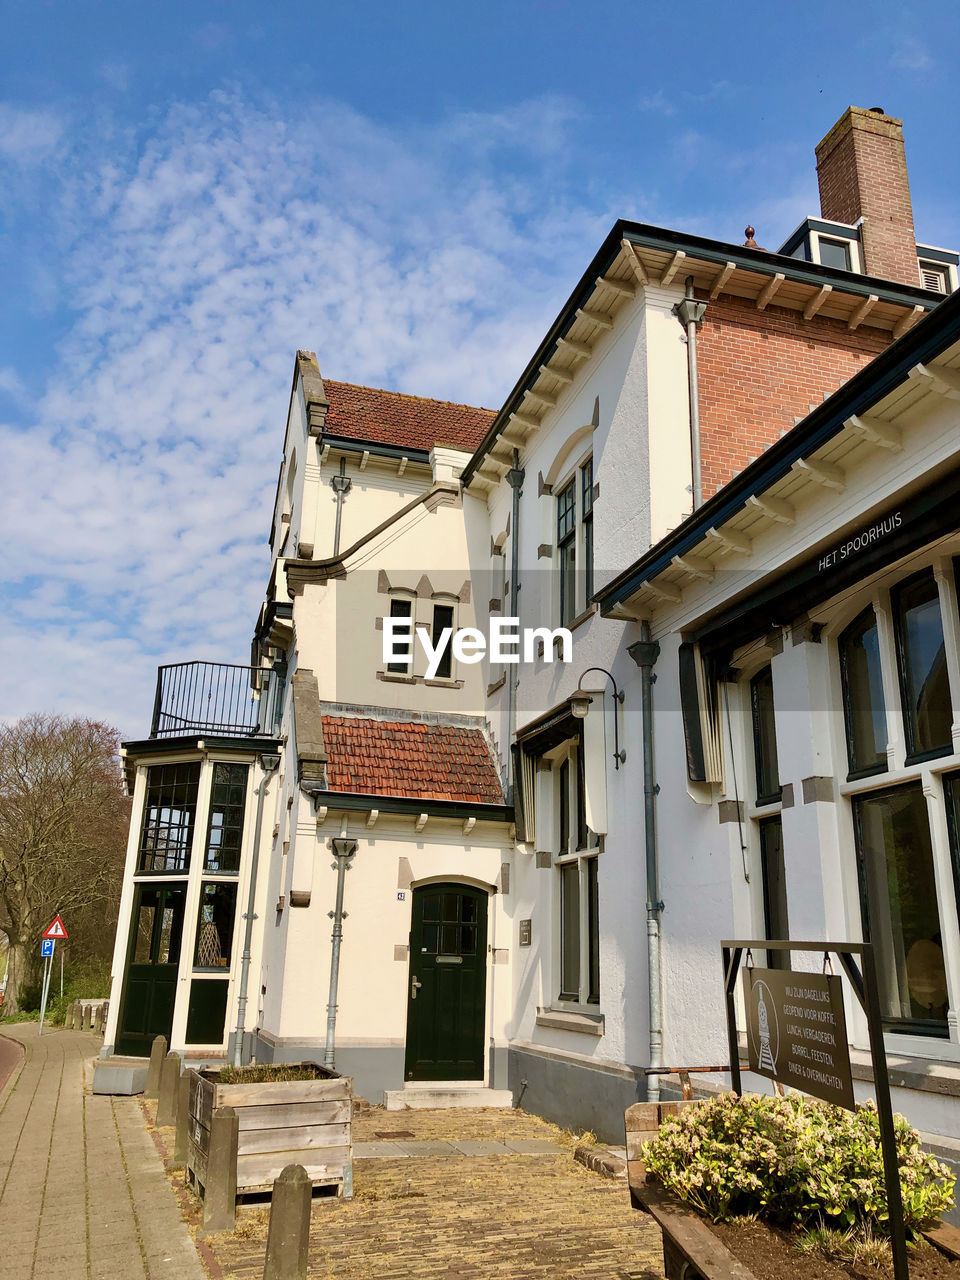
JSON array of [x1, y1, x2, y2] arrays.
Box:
[[0, 1023, 206, 1280]]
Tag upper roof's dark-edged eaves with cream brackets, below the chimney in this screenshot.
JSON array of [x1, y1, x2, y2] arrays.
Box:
[[462, 219, 942, 488]]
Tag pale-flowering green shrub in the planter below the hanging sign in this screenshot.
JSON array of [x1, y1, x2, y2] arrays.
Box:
[[644, 1093, 955, 1234]]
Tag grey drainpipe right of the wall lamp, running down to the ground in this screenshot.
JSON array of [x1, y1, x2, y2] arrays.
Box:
[[627, 622, 663, 1102]]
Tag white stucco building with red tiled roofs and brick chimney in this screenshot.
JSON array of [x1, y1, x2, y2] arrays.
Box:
[[106, 109, 960, 1187]]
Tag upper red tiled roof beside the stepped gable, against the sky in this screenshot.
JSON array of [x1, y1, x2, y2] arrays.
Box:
[[324, 378, 495, 453]]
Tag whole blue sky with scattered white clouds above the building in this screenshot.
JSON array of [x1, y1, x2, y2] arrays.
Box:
[[0, 0, 960, 736]]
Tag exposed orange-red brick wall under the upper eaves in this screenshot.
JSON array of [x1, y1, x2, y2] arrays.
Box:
[[698, 294, 891, 498]]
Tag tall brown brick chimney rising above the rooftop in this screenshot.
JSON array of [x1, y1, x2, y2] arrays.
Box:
[[817, 106, 920, 285]]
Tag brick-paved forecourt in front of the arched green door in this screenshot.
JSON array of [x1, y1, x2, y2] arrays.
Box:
[[151, 1105, 663, 1280]]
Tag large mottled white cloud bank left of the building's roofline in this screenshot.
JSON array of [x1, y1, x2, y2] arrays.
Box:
[[0, 93, 626, 736]]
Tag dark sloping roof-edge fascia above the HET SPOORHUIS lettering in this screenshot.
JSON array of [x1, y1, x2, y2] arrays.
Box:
[[593, 293, 960, 616]]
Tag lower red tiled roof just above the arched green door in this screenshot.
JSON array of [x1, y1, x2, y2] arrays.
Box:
[[323, 716, 503, 804]]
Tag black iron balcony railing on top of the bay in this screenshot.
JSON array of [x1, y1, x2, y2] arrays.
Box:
[[150, 662, 282, 737]]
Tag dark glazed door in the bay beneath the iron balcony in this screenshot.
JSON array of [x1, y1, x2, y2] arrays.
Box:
[[116, 883, 187, 1057]]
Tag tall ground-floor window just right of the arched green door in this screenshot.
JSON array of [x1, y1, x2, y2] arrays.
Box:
[[553, 744, 600, 1006]]
